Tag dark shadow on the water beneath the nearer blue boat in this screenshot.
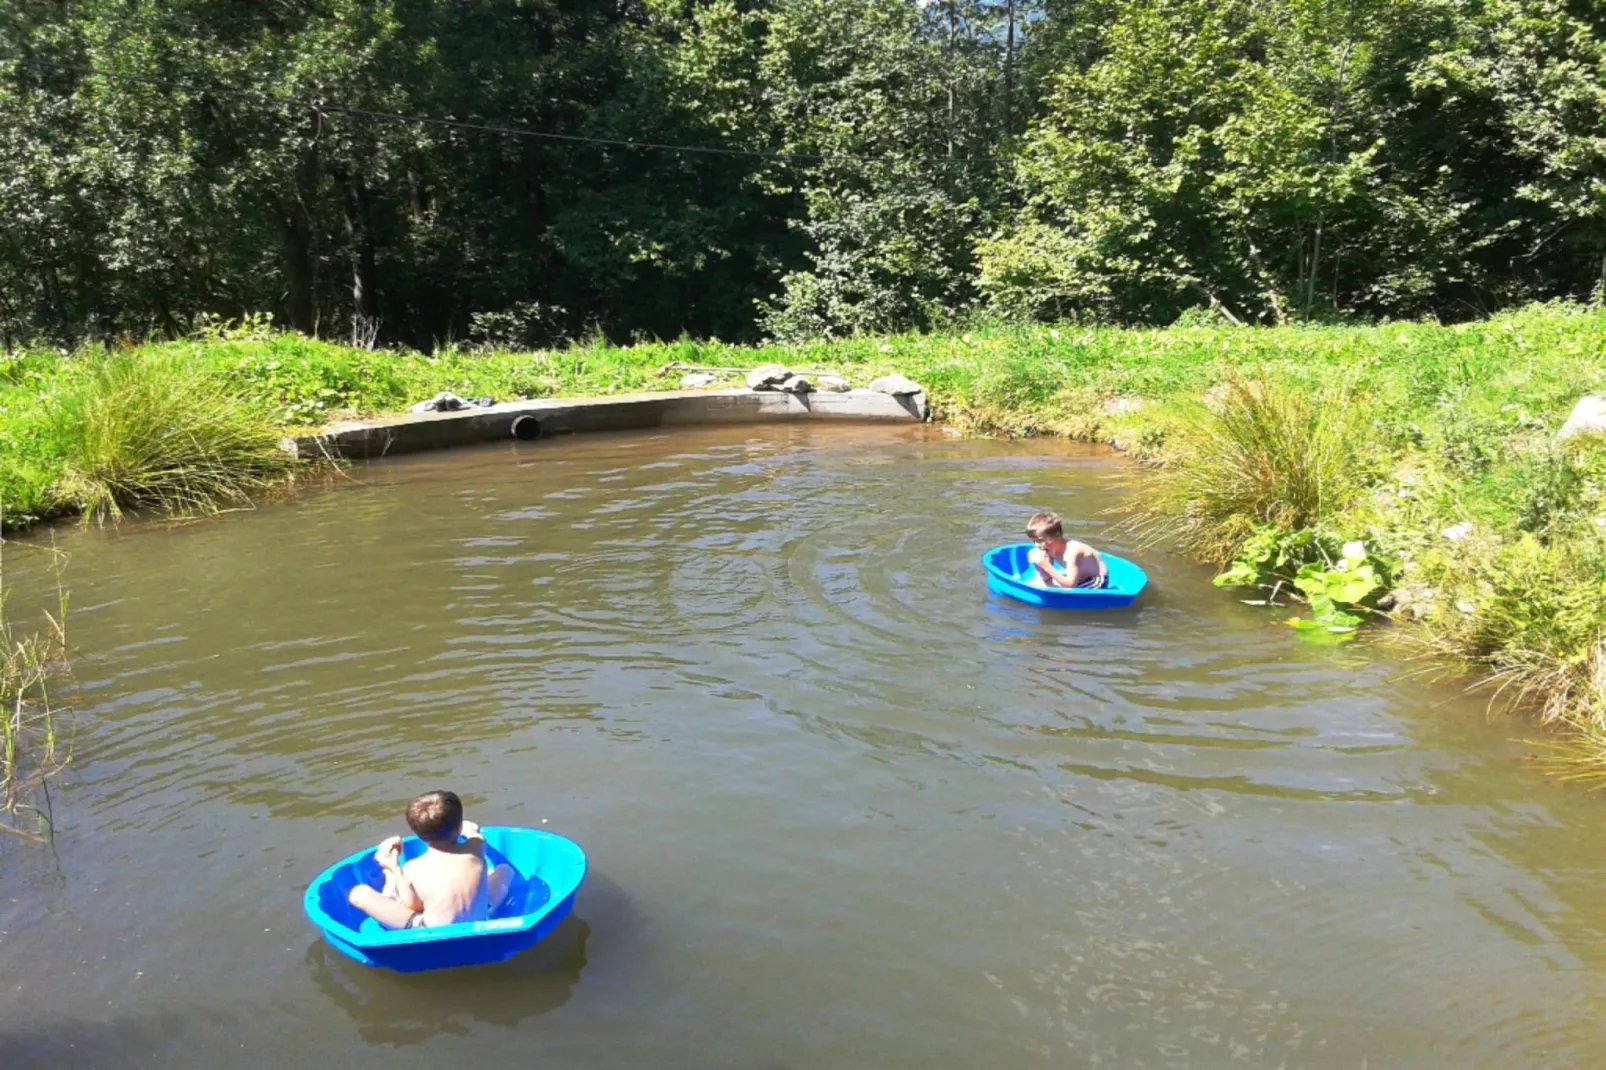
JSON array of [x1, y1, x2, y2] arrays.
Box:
[[305, 916, 591, 1046]]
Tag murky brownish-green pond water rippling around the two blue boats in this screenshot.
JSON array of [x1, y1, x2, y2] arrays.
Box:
[[0, 427, 1606, 1070]]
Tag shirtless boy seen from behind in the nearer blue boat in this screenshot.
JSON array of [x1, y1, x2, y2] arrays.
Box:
[[349, 792, 512, 929]]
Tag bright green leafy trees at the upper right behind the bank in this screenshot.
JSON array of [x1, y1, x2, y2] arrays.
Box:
[[980, 0, 1606, 321]]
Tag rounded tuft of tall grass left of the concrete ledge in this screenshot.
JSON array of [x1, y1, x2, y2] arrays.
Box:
[[50, 353, 296, 519]]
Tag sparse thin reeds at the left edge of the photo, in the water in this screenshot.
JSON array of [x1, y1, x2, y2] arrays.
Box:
[[0, 536, 72, 839]]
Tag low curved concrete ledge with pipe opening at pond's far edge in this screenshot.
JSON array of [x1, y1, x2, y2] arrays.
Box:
[[296, 389, 927, 458]]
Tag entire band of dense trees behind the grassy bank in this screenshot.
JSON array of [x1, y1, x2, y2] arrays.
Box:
[[0, 0, 1606, 345]]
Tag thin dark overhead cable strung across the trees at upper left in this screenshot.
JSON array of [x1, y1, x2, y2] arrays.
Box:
[[8, 56, 999, 164]]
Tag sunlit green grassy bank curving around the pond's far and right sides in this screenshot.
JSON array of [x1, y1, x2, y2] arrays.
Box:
[[9, 307, 1606, 774]]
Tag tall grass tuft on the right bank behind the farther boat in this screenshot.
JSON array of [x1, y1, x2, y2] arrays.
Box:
[[1126, 378, 1367, 566]]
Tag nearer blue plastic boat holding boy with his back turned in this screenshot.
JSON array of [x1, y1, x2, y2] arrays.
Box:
[[302, 826, 586, 974]]
